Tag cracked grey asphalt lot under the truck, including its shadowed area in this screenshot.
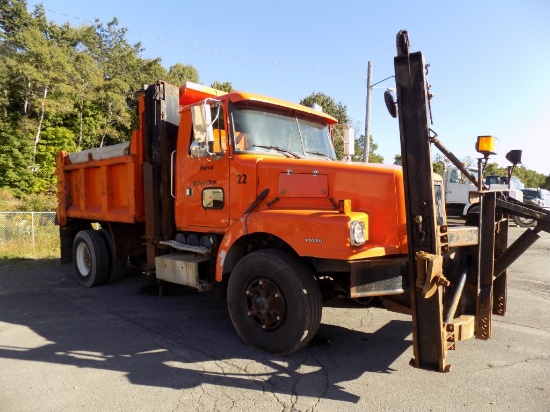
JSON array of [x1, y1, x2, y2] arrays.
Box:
[[0, 227, 550, 412]]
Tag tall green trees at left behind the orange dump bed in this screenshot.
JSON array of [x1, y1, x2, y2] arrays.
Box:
[[0, 0, 199, 196]]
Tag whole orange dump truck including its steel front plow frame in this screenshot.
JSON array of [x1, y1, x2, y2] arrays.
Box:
[[57, 31, 550, 371]]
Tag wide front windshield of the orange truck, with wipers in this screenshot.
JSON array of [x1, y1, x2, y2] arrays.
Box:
[[230, 102, 336, 160]]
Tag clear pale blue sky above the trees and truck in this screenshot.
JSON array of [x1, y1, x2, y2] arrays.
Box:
[[27, 0, 550, 175]]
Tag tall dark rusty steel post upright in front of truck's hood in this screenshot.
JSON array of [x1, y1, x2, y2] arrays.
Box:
[[394, 32, 449, 371]]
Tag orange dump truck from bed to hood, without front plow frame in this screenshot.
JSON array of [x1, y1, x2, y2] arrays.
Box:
[[57, 82, 407, 353]]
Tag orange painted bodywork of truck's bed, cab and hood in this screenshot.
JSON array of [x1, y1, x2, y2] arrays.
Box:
[[57, 83, 407, 281]]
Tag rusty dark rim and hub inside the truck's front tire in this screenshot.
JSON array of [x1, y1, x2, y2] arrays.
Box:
[[246, 278, 286, 331]]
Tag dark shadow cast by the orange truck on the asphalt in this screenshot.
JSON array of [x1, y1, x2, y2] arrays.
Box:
[[0, 266, 411, 403]]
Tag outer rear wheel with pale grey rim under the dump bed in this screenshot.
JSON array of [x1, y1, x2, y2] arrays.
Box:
[[73, 229, 111, 288]]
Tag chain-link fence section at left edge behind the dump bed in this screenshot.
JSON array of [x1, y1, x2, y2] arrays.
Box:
[[0, 212, 60, 258]]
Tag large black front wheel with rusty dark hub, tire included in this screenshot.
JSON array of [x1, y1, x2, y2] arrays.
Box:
[[227, 249, 323, 355]]
